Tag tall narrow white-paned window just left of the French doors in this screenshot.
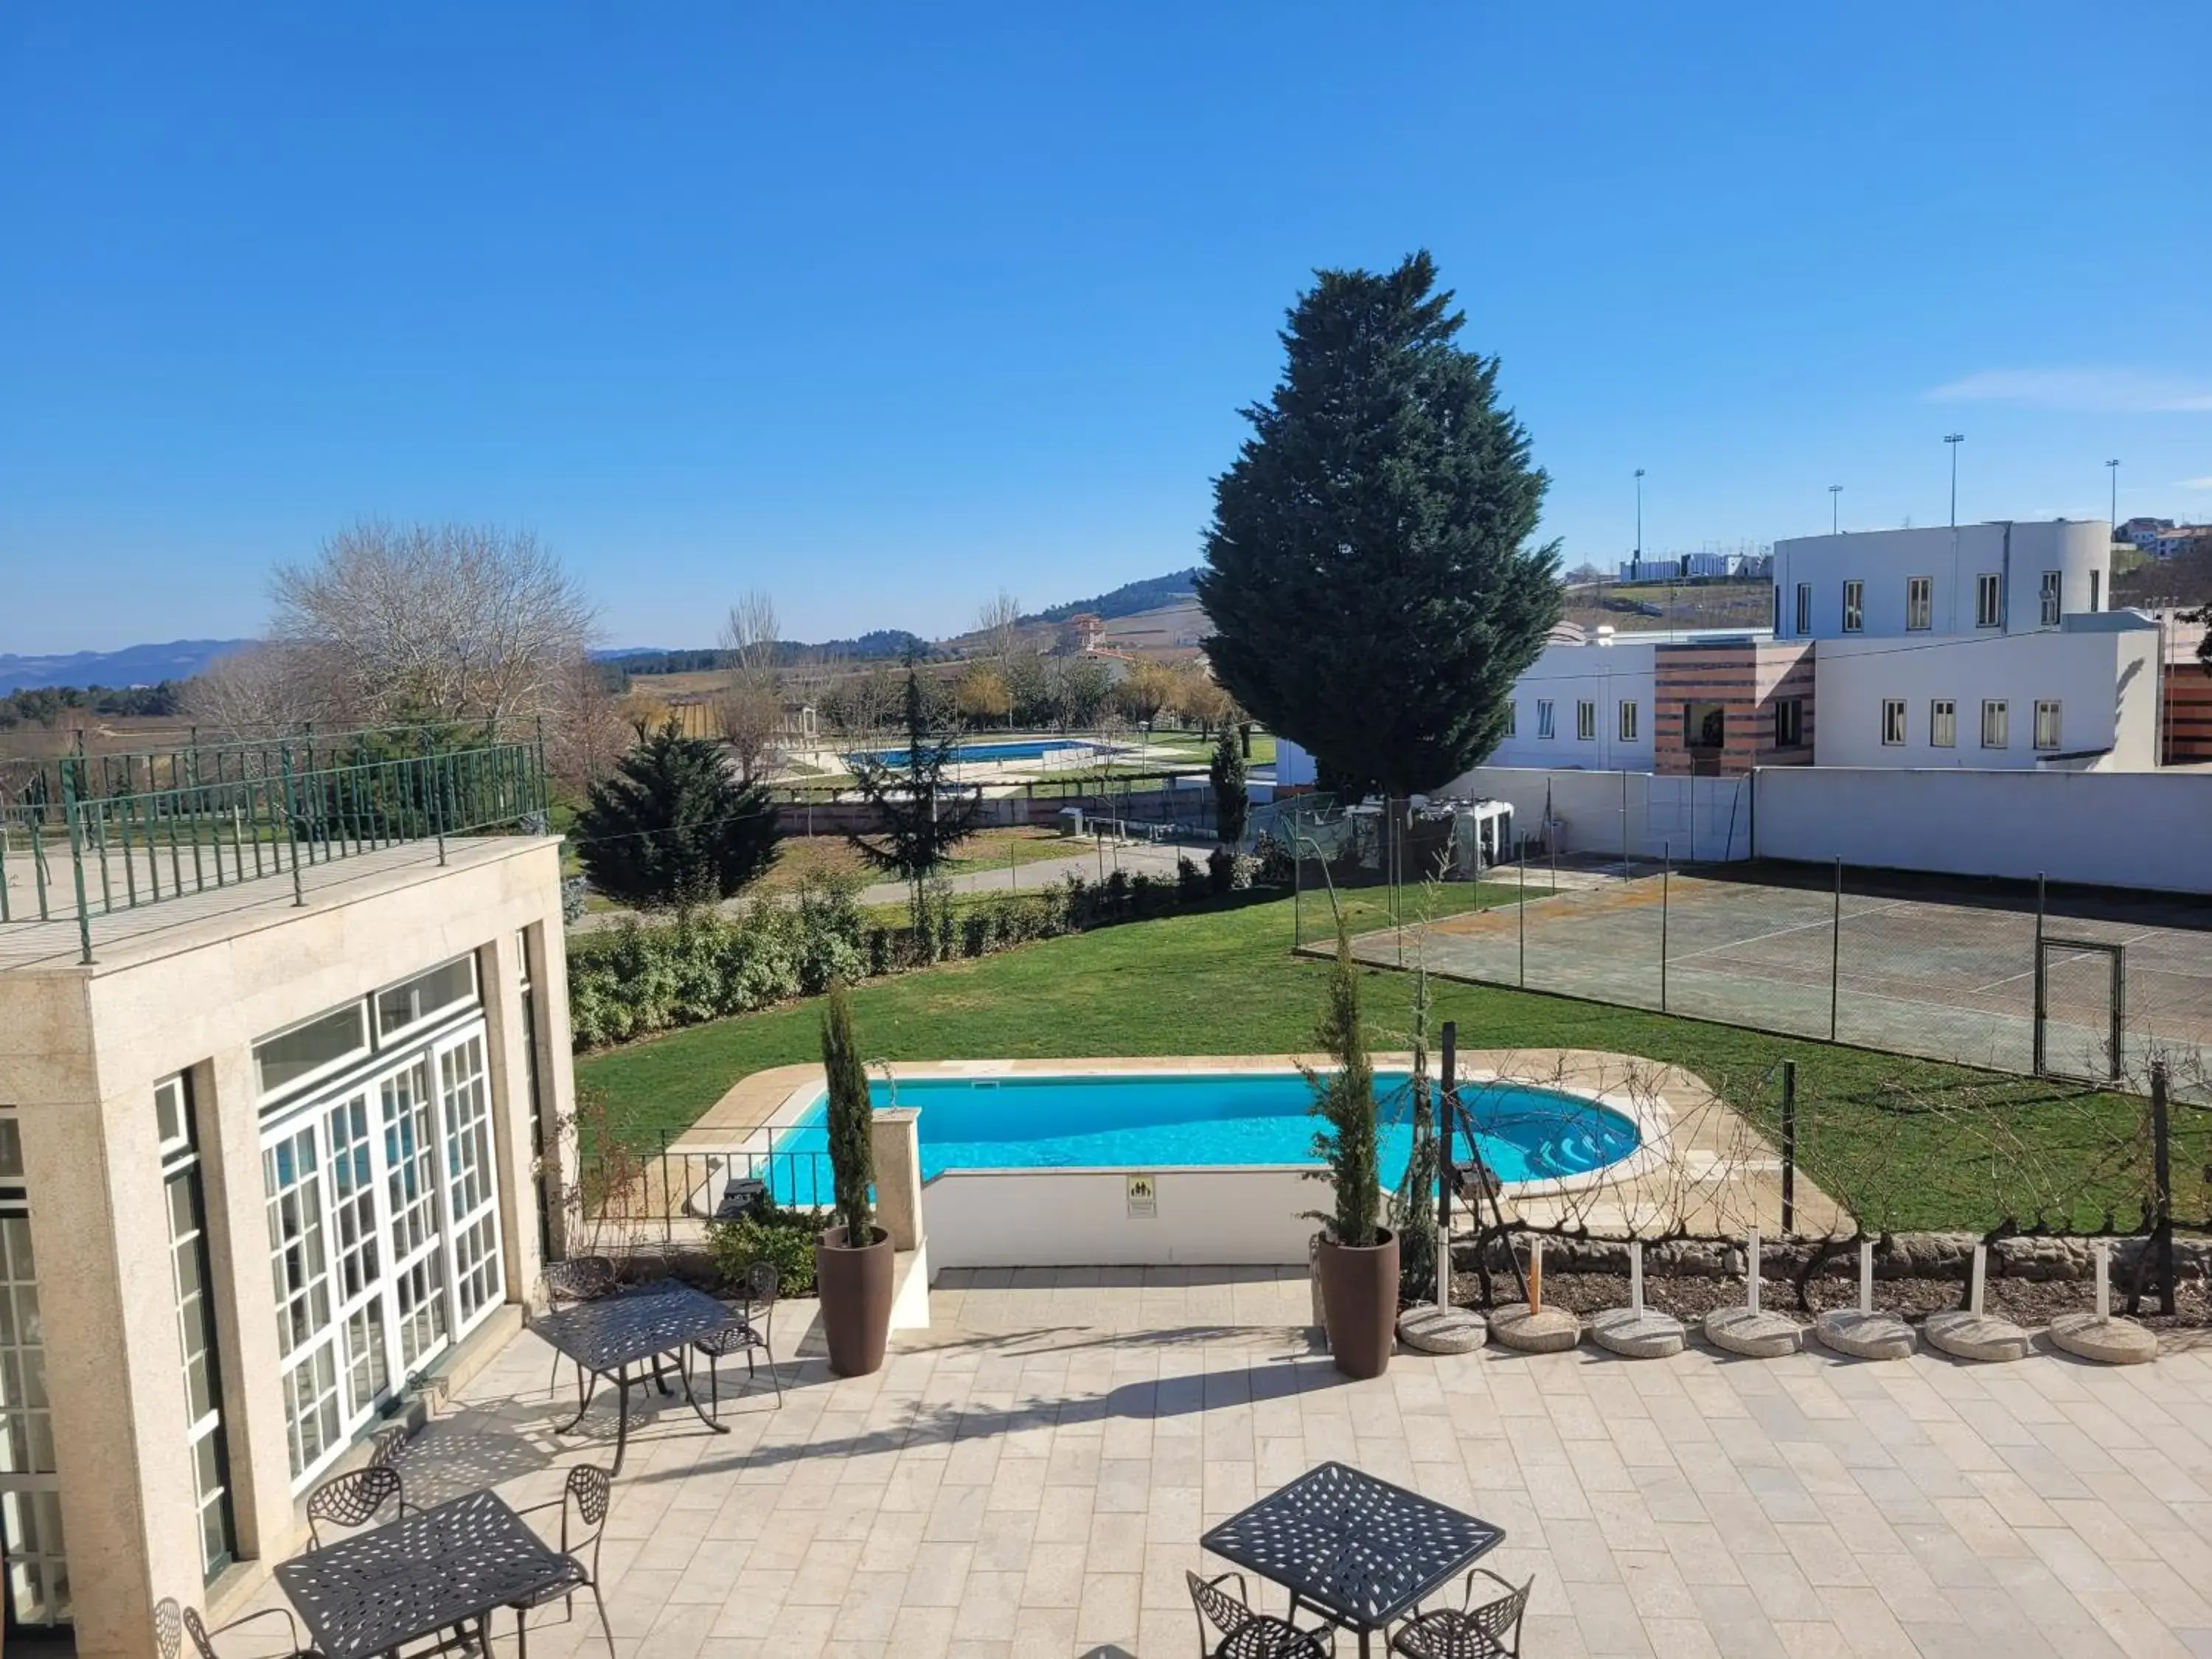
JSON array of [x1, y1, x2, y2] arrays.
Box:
[[153, 1075, 239, 1582]]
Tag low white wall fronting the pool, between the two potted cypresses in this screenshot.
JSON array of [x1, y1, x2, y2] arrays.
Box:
[[922, 1168, 1327, 1272]]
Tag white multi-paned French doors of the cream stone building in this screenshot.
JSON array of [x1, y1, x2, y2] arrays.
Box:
[[261, 1020, 504, 1486]]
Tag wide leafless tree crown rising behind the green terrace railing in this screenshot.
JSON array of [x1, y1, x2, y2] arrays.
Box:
[[270, 520, 595, 732]]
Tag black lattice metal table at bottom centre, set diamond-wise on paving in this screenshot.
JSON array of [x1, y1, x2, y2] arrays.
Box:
[[1199, 1462, 1504, 1659]]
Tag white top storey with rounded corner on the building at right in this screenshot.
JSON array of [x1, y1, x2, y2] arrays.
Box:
[[1774, 518, 2112, 639]]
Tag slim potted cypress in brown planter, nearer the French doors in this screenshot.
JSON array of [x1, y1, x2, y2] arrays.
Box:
[[814, 984, 891, 1376]]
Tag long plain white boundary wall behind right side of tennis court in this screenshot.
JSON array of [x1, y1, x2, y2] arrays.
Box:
[[1756, 765, 2212, 894]]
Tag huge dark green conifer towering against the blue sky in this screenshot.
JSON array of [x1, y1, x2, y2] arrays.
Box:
[[1197, 252, 1559, 796]]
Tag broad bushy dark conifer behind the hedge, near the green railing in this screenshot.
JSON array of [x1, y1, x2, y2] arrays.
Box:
[[575, 721, 776, 909]]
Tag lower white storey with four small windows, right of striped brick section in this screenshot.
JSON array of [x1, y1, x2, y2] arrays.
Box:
[[1814, 613, 2159, 770]]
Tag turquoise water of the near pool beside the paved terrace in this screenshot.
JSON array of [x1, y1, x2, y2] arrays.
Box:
[[768, 1073, 1637, 1203]]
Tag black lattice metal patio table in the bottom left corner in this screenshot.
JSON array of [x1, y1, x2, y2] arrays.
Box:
[[276, 1491, 566, 1659]]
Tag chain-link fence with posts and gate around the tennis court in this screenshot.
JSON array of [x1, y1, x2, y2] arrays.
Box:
[[1270, 796, 2212, 1097]]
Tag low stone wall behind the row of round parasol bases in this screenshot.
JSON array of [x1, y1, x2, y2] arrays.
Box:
[[1451, 1232, 2212, 1283]]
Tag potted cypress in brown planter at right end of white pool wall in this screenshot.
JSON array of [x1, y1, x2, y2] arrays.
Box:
[[1305, 927, 1398, 1378]]
